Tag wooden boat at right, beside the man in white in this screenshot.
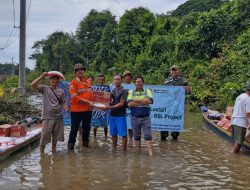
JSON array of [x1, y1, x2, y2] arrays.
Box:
[[202, 109, 250, 151]]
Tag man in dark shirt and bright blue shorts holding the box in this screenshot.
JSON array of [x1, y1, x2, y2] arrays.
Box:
[[103, 74, 128, 151]]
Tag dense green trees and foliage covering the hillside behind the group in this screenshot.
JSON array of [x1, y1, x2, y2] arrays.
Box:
[[0, 0, 250, 108]]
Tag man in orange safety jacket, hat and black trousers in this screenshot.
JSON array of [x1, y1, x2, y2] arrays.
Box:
[[68, 63, 93, 150]]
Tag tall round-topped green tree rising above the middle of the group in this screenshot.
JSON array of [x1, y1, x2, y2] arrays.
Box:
[[116, 7, 155, 70]]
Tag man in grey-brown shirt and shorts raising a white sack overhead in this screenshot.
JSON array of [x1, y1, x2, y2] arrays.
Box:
[[31, 72, 68, 154]]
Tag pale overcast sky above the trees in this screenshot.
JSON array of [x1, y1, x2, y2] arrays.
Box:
[[0, 0, 186, 69]]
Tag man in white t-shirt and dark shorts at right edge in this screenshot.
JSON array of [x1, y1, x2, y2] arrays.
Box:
[[231, 84, 250, 153]]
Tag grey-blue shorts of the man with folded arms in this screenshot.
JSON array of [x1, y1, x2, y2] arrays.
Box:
[[131, 116, 152, 141]]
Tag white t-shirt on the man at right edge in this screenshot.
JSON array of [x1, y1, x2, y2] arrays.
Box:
[[231, 93, 250, 128]]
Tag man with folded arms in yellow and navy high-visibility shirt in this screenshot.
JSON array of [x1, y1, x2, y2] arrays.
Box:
[[127, 76, 153, 156]]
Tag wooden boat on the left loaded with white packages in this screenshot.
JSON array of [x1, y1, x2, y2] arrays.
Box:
[[0, 119, 42, 161]]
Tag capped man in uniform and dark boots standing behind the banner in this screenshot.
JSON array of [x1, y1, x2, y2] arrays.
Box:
[[161, 65, 191, 140]]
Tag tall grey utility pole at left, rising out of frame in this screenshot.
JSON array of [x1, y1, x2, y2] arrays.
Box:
[[18, 0, 26, 94]]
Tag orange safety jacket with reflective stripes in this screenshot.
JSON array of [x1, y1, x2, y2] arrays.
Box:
[[69, 77, 93, 112]]
